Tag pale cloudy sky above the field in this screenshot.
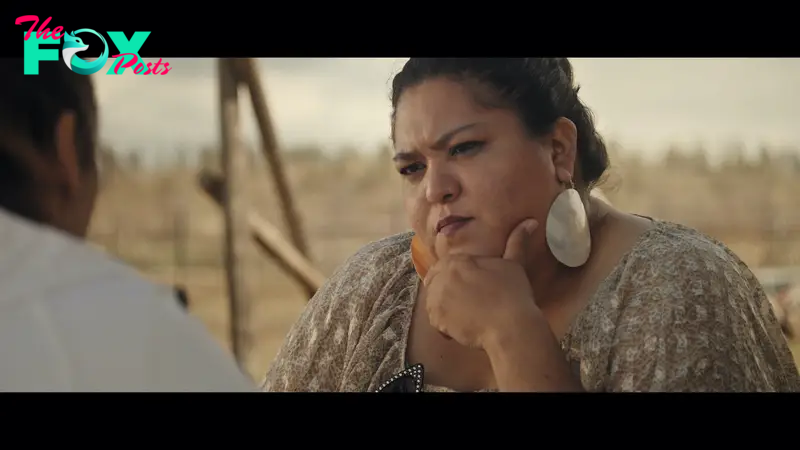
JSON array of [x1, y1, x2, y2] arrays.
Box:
[[94, 58, 800, 165]]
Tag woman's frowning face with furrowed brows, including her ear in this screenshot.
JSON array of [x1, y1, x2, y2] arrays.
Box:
[[394, 78, 576, 257]]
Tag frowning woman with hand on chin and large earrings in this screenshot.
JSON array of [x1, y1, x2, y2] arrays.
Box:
[[263, 58, 800, 392]]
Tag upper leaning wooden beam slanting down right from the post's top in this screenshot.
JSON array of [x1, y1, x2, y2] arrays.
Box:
[[230, 58, 308, 256]]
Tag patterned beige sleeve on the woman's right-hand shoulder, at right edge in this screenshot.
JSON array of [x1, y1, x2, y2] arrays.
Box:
[[605, 240, 800, 392]]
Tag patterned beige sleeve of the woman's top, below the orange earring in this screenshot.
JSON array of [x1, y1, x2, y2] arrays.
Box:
[[261, 234, 410, 392]]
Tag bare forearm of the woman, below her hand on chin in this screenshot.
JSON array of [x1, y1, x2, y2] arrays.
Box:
[[485, 318, 583, 392]]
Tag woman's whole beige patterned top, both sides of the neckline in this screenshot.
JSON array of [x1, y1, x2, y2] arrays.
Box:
[[262, 221, 800, 392]]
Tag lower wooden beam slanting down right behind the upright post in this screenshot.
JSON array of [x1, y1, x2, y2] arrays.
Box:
[[199, 172, 326, 299]]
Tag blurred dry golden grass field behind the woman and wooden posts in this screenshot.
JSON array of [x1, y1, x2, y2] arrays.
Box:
[[90, 145, 800, 379]]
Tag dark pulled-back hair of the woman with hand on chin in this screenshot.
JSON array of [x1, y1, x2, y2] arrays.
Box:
[[392, 58, 609, 190]]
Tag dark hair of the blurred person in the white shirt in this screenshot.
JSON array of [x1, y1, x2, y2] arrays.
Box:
[[0, 58, 97, 221]]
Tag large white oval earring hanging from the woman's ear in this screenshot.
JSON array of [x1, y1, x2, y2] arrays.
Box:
[[545, 179, 592, 267]]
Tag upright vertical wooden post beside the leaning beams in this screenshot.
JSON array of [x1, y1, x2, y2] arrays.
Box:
[[217, 59, 250, 366]]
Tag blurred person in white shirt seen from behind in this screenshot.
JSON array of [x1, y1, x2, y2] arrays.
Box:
[[0, 59, 256, 392]]
